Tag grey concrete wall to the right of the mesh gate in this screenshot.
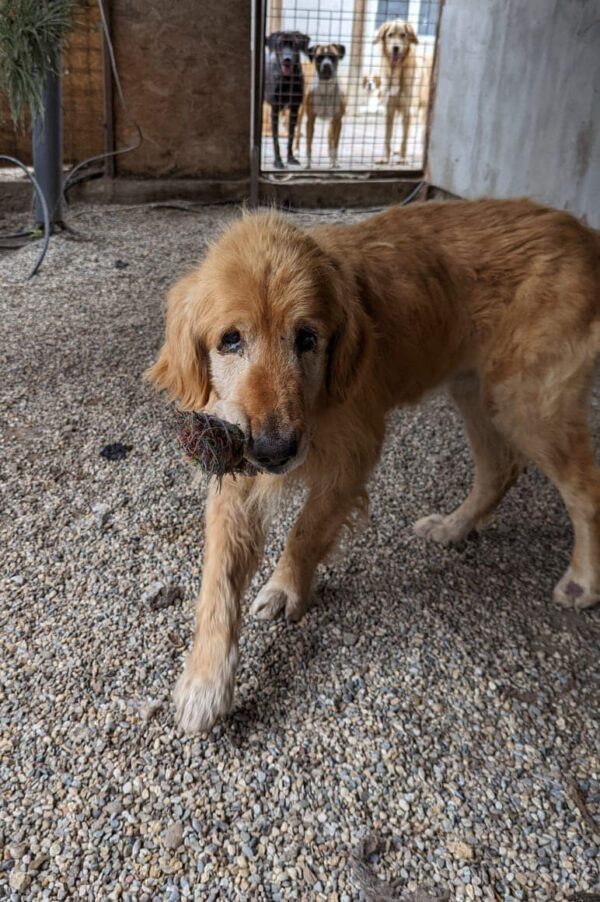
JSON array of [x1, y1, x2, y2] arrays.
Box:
[[428, 0, 600, 227]]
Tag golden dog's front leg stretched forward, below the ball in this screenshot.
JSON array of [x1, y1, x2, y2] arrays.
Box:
[[174, 476, 264, 733]]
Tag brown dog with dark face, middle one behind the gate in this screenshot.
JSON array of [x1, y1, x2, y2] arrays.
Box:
[[296, 44, 346, 169]]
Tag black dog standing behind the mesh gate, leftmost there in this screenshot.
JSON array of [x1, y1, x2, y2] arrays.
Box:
[[265, 31, 310, 169]]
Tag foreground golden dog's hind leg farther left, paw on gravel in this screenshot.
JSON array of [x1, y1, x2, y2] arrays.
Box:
[[414, 373, 525, 544]]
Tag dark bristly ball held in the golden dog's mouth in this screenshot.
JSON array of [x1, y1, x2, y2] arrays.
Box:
[[178, 413, 257, 482]]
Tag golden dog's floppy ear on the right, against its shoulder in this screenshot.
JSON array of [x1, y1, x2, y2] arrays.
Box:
[[326, 274, 373, 404]]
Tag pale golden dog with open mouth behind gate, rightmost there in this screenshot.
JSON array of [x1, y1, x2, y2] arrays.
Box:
[[373, 19, 431, 163]]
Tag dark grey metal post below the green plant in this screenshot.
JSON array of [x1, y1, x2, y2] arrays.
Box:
[[32, 66, 62, 228]]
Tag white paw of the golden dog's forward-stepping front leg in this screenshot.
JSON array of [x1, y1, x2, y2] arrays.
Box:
[[173, 649, 238, 734]]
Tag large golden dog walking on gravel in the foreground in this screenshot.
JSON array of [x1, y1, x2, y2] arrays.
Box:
[[148, 200, 600, 733]]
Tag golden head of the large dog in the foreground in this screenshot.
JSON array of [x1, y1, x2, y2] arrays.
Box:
[[147, 213, 371, 473]]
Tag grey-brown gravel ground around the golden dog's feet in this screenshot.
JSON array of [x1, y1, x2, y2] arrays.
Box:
[[0, 201, 600, 902]]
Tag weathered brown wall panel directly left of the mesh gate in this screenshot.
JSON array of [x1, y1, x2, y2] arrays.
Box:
[[111, 0, 250, 179]]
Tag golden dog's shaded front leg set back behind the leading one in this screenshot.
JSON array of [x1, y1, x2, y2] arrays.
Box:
[[250, 482, 367, 621]]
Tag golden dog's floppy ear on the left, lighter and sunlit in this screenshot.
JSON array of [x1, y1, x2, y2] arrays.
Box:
[[145, 273, 210, 410]]
